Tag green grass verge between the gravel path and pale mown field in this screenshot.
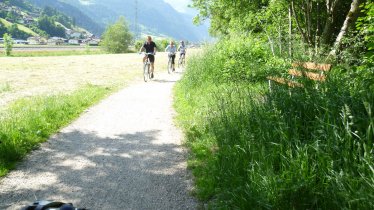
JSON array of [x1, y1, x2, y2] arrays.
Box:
[[0, 85, 113, 177]]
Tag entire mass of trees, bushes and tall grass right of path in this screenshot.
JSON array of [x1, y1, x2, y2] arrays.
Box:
[[175, 0, 374, 209]]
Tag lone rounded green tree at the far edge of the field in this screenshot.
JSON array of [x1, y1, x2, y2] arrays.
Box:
[[100, 16, 133, 53]]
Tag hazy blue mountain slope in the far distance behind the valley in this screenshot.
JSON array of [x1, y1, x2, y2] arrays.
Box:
[[30, 0, 209, 41]]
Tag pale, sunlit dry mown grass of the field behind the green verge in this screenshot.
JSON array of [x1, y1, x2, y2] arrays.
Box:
[[0, 53, 172, 106]]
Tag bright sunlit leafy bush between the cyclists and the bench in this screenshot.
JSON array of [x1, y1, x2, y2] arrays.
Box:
[[186, 36, 286, 86]]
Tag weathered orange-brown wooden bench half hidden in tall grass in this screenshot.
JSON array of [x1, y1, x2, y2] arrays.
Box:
[[267, 62, 332, 90]]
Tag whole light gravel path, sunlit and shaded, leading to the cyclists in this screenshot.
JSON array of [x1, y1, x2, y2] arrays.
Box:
[[0, 69, 197, 209]]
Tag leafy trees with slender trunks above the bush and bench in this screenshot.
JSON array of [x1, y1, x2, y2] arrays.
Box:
[[192, 0, 368, 55]]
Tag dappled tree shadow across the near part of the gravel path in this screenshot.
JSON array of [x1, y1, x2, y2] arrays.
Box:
[[0, 130, 195, 209]]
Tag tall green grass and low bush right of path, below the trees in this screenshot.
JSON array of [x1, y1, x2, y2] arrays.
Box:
[[175, 36, 374, 209]]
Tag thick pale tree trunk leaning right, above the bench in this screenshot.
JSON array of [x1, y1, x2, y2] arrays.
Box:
[[329, 0, 365, 56]]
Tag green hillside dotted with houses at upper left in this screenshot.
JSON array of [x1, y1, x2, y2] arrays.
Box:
[[0, 0, 98, 39]]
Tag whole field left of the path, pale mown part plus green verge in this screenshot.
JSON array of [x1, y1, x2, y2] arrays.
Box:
[[0, 53, 172, 177]]
